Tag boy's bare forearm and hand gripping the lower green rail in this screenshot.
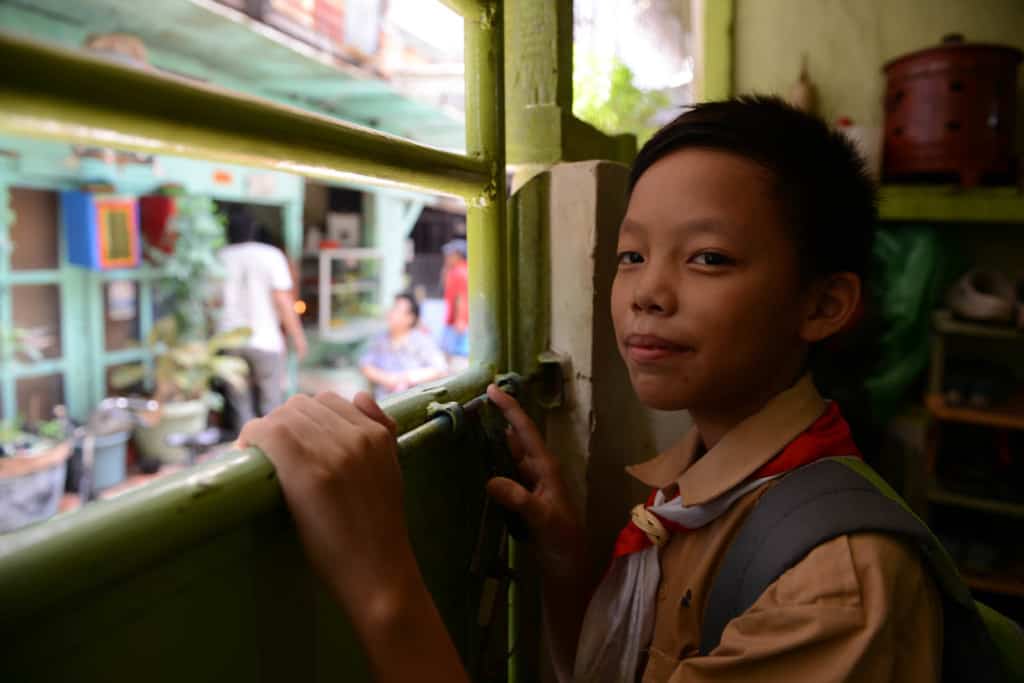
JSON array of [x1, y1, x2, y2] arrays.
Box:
[[239, 393, 469, 683]]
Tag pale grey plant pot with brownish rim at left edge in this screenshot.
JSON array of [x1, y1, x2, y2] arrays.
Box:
[[0, 441, 72, 533]]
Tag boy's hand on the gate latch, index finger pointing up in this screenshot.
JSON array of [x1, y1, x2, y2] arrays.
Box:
[[487, 384, 587, 580]]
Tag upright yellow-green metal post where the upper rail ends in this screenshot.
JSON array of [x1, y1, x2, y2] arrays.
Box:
[[465, 1, 508, 372]]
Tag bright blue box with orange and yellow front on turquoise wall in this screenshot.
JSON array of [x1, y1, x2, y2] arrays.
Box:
[[60, 190, 141, 270]]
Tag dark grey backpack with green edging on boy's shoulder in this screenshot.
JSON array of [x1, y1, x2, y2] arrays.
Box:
[[700, 458, 1024, 683]]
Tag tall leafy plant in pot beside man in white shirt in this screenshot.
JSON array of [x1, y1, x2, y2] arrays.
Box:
[[112, 197, 251, 463]]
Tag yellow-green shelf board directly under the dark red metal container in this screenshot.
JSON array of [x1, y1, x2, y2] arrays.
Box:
[[879, 185, 1024, 223]]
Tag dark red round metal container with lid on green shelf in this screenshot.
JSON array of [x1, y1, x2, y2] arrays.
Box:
[[883, 35, 1022, 187]]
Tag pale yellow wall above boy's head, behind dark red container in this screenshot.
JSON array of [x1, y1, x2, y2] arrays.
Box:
[[733, 0, 1024, 139]]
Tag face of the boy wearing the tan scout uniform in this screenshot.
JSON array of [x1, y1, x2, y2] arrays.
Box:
[[611, 148, 809, 411]]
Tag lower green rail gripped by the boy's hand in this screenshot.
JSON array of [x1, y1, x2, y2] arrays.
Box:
[[0, 362, 490, 625]]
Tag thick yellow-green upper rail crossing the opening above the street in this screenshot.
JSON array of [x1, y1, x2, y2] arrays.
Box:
[[0, 33, 494, 204]]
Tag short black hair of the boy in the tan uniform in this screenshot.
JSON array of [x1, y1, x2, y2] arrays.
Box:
[[630, 95, 878, 289]]
